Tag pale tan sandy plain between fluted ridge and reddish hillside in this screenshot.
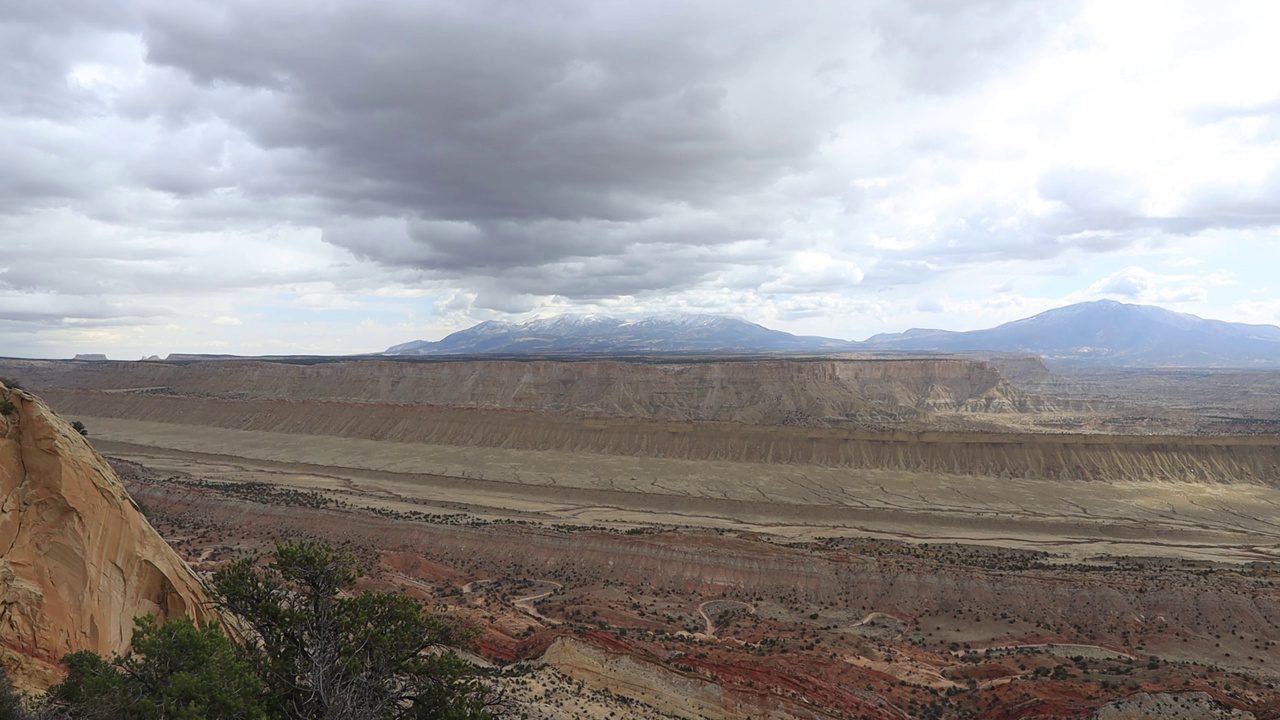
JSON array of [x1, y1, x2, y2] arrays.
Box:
[[77, 418, 1280, 561]]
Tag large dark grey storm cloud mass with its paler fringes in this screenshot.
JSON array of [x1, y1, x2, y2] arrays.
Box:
[[124, 1, 1075, 297]]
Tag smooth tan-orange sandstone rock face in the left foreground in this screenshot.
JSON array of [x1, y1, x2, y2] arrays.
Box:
[[0, 384, 215, 685]]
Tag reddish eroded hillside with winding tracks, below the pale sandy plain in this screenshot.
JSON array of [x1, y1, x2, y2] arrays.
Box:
[[128, 465, 1280, 720]]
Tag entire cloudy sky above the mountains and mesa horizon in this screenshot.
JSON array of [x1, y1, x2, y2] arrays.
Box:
[[0, 0, 1280, 360]]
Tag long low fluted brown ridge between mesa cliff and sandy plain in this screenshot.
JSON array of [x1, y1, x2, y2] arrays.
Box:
[[40, 392, 1280, 486]]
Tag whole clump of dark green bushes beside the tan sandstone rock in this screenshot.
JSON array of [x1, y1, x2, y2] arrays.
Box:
[[41, 542, 494, 720]]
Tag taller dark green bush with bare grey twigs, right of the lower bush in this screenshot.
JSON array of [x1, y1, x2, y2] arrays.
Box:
[[214, 542, 492, 720]]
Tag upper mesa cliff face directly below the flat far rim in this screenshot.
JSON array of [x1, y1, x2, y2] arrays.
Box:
[[0, 357, 1050, 425]]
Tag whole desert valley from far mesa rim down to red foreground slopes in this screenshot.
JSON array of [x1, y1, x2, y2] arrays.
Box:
[[0, 303, 1280, 719]]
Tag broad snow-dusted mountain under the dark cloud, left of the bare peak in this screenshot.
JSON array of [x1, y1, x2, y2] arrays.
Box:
[[385, 314, 852, 355]]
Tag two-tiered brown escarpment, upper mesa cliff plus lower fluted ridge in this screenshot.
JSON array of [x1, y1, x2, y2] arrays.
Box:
[[12, 357, 1280, 486]]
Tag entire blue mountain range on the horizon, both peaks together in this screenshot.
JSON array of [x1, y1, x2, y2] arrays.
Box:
[[384, 300, 1280, 368]]
